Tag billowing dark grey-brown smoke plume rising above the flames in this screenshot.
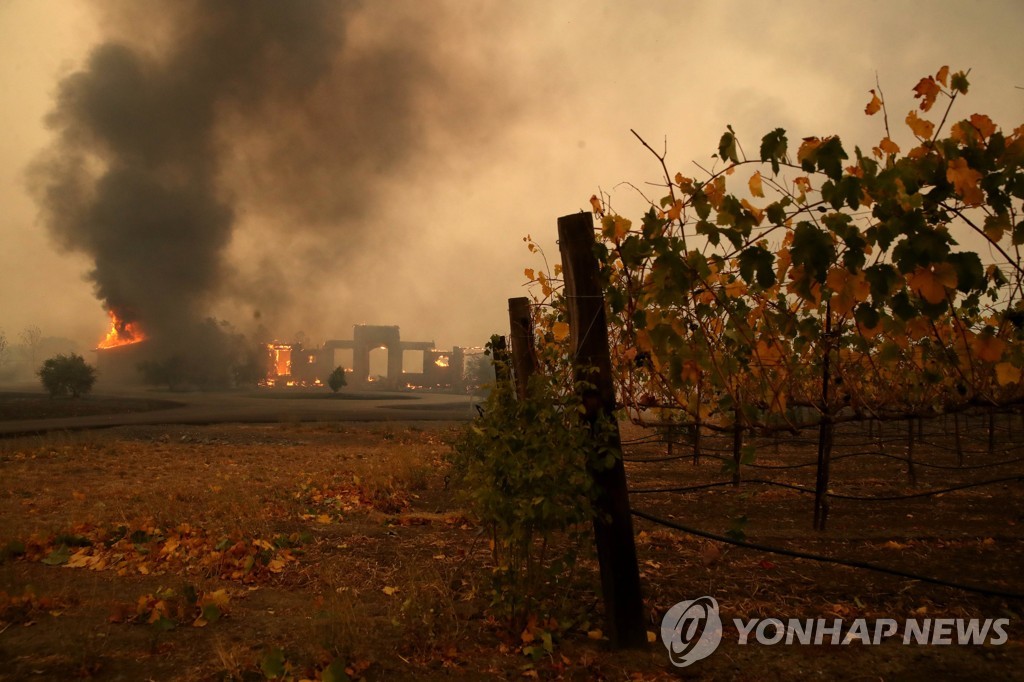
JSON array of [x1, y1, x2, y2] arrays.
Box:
[[30, 0, 501, 346]]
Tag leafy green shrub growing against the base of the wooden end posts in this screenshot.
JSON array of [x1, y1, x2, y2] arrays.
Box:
[[452, 346, 614, 631]]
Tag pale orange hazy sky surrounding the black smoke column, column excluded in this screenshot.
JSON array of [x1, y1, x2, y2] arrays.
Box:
[[0, 0, 1024, 356]]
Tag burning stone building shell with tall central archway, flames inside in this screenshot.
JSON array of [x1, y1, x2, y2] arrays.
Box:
[[267, 325, 465, 390]]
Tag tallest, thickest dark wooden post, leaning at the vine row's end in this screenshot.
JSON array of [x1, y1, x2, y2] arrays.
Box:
[[558, 213, 647, 648]]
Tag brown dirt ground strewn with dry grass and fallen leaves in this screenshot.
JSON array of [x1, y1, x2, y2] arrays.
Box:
[[0, 405, 1024, 680]]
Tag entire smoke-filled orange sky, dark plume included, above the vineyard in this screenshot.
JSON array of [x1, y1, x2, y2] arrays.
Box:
[[0, 0, 1024, 366]]
